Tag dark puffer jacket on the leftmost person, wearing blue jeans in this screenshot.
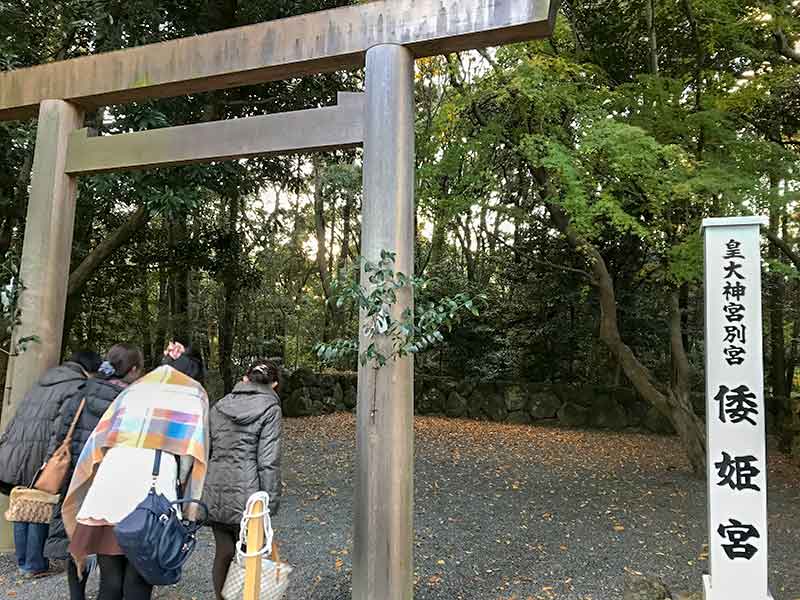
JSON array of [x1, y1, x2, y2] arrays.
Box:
[[0, 362, 86, 494]]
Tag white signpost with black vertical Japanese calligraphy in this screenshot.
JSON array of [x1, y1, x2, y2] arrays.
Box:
[[703, 217, 771, 600]]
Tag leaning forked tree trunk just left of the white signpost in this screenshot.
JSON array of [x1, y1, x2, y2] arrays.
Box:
[[547, 203, 706, 476]]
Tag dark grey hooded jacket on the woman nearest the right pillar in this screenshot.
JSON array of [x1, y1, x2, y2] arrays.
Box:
[[203, 383, 282, 525]]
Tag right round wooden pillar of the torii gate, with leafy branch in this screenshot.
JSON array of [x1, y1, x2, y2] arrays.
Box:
[[353, 44, 414, 600]]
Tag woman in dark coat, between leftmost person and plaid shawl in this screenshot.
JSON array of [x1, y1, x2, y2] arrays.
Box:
[[44, 344, 144, 600]]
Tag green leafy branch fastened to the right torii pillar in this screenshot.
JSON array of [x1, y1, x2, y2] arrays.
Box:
[[314, 250, 486, 369]]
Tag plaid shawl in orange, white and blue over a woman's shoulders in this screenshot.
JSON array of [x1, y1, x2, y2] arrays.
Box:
[[62, 366, 208, 537]]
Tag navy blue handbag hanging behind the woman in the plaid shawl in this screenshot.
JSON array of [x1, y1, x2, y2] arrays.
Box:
[[114, 450, 208, 585]]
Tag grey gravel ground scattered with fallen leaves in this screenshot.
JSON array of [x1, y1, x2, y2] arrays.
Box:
[[0, 414, 800, 600]]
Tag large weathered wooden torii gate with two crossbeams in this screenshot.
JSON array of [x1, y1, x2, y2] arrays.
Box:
[[0, 0, 559, 600]]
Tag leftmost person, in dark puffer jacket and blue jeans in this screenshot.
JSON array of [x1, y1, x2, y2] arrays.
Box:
[[0, 352, 100, 575]]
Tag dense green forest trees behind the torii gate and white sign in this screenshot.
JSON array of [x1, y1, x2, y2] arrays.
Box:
[[0, 0, 800, 468]]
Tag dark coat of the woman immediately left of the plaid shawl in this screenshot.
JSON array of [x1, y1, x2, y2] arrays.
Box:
[[44, 379, 124, 560]]
